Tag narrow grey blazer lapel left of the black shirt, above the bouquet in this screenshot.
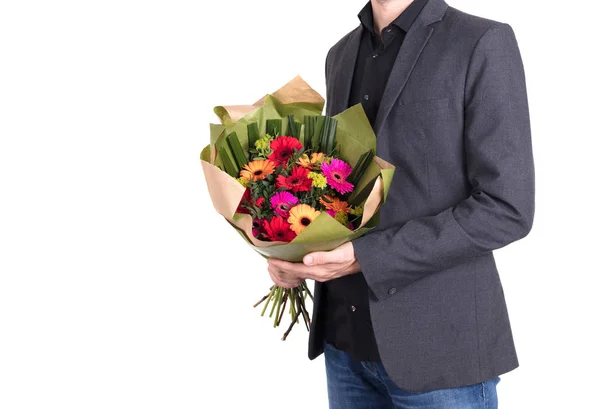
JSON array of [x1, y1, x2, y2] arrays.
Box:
[[328, 26, 363, 116]]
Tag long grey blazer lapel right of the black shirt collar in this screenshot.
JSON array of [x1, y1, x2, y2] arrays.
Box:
[[374, 0, 448, 134]]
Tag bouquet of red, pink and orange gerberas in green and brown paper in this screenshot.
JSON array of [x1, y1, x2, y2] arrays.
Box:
[[200, 77, 394, 340]]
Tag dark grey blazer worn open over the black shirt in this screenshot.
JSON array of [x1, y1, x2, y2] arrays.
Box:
[[309, 0, 534, 391]]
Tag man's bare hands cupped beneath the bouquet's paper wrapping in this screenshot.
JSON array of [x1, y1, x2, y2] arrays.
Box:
[[268, 242, 360, 288]]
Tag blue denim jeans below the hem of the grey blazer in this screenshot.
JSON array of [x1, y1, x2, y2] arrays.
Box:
[[325, 343, 500, 409]]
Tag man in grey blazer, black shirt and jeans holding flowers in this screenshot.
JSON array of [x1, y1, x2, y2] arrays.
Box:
[[269, 0, 534, 409]]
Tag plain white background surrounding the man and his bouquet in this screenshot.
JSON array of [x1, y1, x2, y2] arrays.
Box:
[[0, 0, 600, 409]]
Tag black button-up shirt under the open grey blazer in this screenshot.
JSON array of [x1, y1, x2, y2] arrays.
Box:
[[324, 0, 428, 361]]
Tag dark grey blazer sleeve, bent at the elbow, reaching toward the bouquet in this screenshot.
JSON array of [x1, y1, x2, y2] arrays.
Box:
[[353, 23, 534, 300]]
